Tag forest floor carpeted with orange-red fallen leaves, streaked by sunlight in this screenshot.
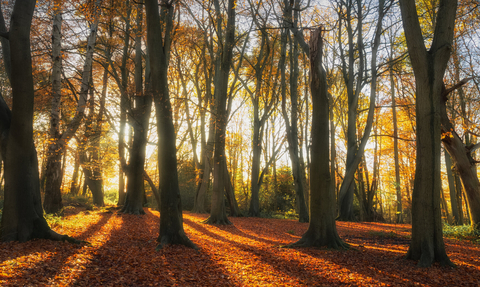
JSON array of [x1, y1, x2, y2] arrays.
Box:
[[0, 207, 480, 286]]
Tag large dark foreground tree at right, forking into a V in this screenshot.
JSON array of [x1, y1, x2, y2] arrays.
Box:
[[400, 0, 457, 267]]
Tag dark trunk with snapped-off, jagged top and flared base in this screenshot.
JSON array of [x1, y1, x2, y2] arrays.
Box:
[[291, 28, 348, 249]]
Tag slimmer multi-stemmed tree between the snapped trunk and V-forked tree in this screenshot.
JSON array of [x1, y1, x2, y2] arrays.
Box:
[[338, 0, 393, 221]]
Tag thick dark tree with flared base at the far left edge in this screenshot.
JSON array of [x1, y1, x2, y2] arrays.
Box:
[[0, 0, 78, 242]]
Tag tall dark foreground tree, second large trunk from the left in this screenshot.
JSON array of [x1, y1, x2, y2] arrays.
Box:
[[145, 0, 196, 250]]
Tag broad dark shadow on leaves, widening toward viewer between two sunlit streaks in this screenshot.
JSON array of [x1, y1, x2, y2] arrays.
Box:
[[68, 210, 235, 286]]
